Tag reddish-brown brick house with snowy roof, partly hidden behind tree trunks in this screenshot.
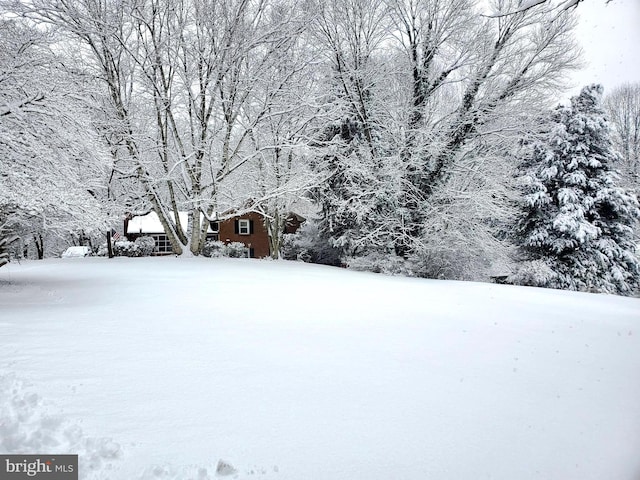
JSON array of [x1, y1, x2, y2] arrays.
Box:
[[124, 212, 305, 258]]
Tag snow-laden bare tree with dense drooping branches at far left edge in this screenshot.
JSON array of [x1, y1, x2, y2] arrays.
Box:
[[0, 20, 108, 258]]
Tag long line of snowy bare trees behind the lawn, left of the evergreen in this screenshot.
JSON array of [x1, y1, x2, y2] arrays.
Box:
[[0, 0, 636, 292]]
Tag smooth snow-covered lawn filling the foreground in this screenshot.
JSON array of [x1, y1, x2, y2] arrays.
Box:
[[0, 258, 640, 480]]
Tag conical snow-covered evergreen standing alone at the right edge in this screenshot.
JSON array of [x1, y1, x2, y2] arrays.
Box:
[[512, 85, 640, 295]]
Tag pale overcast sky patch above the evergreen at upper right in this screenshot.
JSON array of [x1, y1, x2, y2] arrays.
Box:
[[569, 0, 640, 95]]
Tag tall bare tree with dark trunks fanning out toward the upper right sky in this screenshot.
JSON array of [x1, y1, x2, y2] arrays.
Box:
[[382, 0, 579, 256]]
